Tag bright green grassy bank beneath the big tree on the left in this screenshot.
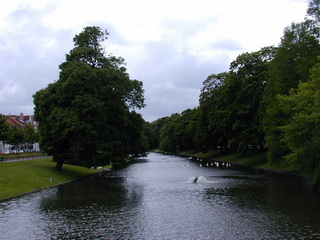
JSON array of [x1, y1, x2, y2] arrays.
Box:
[[0, 158, 108, 199]]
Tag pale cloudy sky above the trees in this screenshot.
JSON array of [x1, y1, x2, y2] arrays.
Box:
[[0, 0, 309, 122]]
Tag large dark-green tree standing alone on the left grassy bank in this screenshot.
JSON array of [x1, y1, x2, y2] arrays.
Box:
[[34, 26, 144, 170]]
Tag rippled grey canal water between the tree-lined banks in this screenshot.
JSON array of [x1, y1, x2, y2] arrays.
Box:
[[0, 153, 320, 240]]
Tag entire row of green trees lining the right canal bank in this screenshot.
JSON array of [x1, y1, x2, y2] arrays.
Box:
[[147, 0, 320, 184]]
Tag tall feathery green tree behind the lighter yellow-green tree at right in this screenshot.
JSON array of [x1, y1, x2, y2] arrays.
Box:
[[264, 17, 320, 163]]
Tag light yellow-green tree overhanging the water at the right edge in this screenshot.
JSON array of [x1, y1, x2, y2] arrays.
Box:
[[278, 58, 320, 188]]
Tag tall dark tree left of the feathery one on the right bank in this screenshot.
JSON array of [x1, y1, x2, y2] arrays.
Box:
[[228, 47, 276, 155]]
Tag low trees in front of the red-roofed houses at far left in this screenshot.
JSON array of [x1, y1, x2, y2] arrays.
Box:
[[0, 114, 39, 151]]
